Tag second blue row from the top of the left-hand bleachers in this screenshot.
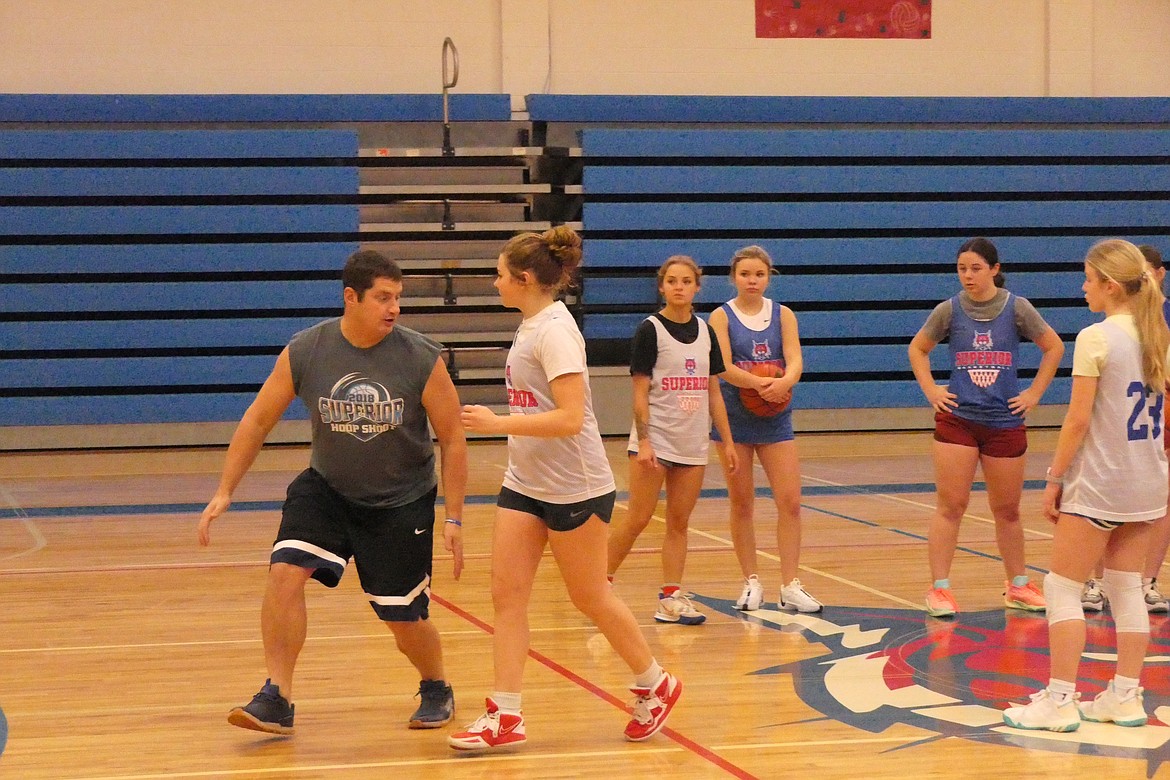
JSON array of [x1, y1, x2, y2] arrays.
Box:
[[0, 129, 358, 160]]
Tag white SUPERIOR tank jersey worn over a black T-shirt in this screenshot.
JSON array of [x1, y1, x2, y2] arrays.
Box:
[[628, 317, 711, 465]]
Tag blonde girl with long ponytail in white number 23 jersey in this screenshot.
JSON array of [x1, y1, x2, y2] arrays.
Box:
[[1004, 240, 1170, 732]]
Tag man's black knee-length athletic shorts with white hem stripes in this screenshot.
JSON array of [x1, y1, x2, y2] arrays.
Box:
[[270, 469, 438, 622]]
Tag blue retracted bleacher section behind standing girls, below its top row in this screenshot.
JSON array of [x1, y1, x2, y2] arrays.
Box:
[[570, 118, 1170, 427]]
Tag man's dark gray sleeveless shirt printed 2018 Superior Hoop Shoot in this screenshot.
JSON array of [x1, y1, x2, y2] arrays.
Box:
[[289, 318, 442, 506]]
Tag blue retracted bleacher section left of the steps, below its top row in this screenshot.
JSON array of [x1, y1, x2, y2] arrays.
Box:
[[0, 130, 358, 426]]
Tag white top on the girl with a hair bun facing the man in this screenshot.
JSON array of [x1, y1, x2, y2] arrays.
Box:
[[504, 301, 617, 504]]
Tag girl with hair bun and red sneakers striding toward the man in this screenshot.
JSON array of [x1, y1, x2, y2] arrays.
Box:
[[447, 227, 682, 750]]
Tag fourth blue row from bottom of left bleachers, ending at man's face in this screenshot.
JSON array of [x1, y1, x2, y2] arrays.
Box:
[[0, 279, 340, 312]]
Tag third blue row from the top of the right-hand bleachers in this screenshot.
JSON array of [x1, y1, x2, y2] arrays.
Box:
[[583, 164, 1170, 194]]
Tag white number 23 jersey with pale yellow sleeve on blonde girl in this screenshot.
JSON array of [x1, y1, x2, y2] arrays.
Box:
[[1060, 315, 1166, 523]]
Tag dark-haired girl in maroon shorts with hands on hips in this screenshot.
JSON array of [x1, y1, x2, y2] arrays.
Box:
[[909, 239, 1065, 617]]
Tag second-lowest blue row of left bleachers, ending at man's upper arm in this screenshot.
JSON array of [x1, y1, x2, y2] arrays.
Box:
[[0, 356, 276, 392]]
